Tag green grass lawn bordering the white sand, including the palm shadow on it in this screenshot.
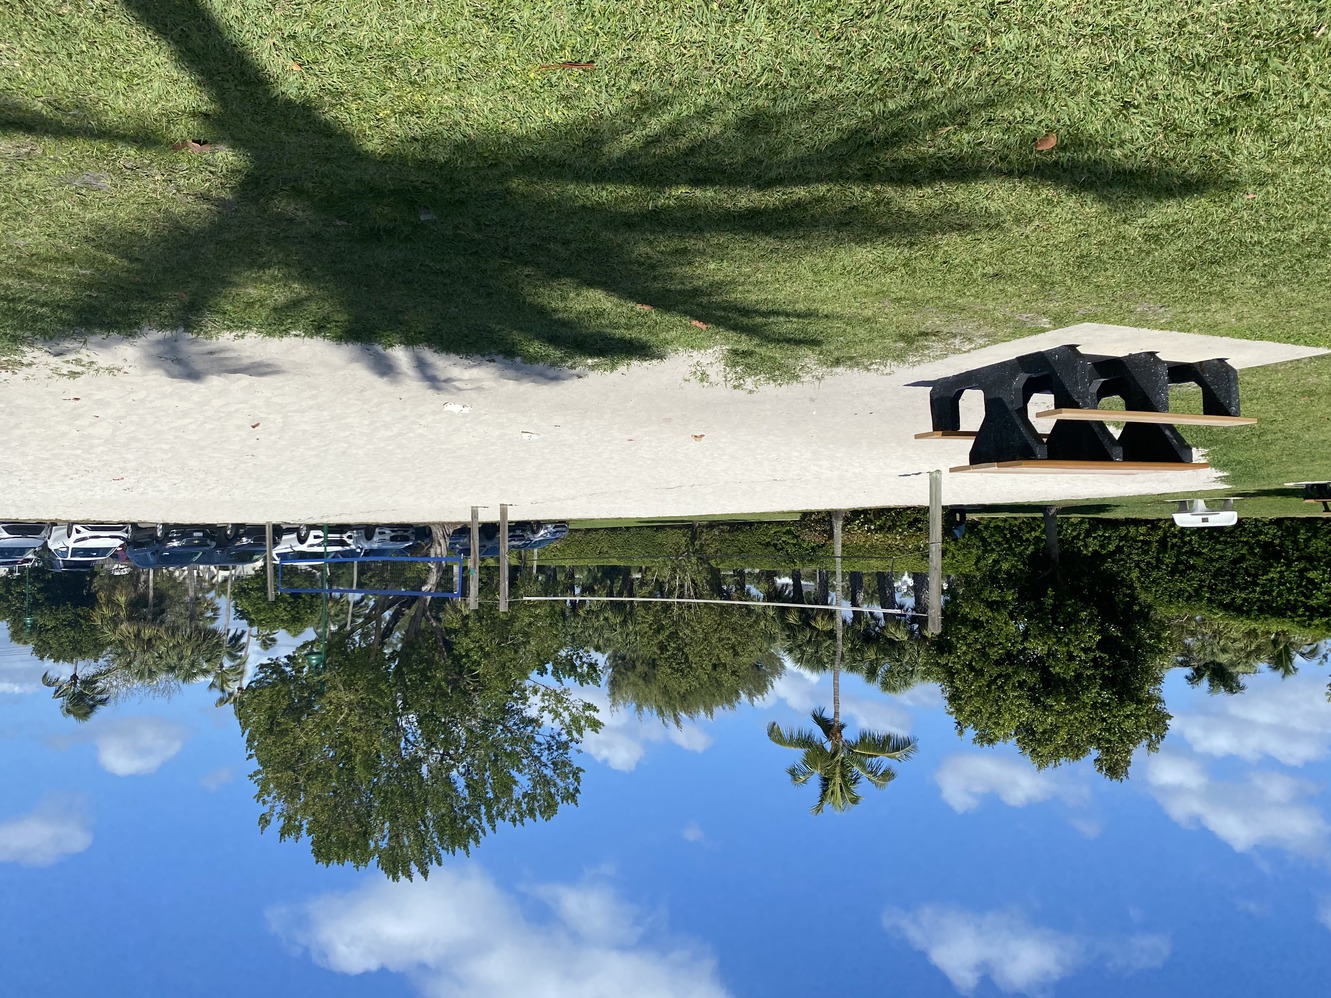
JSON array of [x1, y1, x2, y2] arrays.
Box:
[[0, 0, 1331, 378]]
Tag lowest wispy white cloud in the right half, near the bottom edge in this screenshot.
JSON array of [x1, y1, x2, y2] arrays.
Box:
[[882, 905, 1170, 995]]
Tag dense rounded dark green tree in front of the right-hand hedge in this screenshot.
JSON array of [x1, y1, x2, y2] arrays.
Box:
[[929, 540, 1169, 780]]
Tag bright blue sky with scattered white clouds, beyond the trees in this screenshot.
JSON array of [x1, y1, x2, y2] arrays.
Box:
[[0, 633, 1331, 998]]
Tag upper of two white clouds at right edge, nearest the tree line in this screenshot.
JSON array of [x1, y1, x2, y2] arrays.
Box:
[[1170, 675, 1331, 766]]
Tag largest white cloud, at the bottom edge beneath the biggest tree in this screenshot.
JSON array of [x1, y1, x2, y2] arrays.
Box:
[[268, 866, 727, 998]]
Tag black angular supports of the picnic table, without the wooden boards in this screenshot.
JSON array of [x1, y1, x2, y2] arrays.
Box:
[[929, 346, 1239, 466]]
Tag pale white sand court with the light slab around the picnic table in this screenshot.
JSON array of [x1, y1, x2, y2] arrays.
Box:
[[0, 323, 1326, 523]]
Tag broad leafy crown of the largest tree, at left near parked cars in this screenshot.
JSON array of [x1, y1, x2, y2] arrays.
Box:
[[232, 600, 599, 880]]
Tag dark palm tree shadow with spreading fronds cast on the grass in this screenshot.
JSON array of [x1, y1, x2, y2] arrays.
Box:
[[0, 0, 1209, 377]]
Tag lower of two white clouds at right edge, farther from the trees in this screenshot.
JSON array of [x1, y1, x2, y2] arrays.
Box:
[[1146, 750, 1328, 856]]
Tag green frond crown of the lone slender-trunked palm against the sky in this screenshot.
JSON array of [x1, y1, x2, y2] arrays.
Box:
[[767, 708, 916, 814]]
